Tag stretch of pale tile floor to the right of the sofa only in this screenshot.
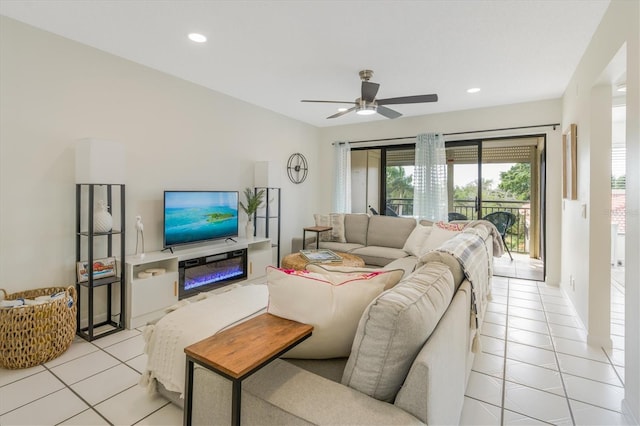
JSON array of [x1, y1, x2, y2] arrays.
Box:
[[460, 277, 631, 425]]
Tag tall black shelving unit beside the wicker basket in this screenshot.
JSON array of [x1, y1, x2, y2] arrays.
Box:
[[76, 184, 126, 341]]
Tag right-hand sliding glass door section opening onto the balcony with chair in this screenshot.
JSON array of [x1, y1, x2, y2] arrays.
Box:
[[447, 137, 544, 258]]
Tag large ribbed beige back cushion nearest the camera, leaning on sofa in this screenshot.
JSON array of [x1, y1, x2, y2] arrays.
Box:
[[342, 263, 454, 402]]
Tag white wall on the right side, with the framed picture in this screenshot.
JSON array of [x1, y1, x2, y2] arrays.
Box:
[[562, 0, 640, 422]]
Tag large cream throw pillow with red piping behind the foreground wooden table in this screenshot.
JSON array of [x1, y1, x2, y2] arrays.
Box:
[[267, 266, 402, 359]]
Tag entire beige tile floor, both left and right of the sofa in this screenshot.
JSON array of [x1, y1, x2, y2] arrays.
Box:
[[0, 277, 625, 426]]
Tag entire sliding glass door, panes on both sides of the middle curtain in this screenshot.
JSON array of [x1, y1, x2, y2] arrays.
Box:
[[351, 136, 544, 264]]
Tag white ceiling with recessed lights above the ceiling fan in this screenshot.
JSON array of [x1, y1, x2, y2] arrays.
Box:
[[0, 0, 609, 127]]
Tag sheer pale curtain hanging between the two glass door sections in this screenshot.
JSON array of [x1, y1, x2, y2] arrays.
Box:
[[413, 133, 448, 221]]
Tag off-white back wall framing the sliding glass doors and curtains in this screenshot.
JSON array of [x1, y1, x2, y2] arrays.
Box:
[[320, 99, 562, 285]]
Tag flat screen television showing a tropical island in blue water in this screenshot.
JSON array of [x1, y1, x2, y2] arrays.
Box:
[[163, 191, 238, 248]]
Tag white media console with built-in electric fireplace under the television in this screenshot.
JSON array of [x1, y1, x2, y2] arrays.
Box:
[[125, 238, 272, 329]]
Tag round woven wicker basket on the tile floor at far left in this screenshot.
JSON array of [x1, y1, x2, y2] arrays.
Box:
[[0, 286, 77, 369]]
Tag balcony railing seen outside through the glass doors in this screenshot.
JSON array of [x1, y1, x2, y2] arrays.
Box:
[[387, 198, 531, 253]]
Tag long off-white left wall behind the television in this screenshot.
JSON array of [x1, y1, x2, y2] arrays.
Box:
[[0, 17, 319, 292]]
